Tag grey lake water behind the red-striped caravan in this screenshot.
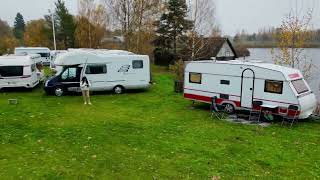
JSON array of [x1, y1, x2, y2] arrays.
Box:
[[249, 48, 320, 101]]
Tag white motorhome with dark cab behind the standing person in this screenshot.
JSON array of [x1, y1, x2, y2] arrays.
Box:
[[45, 51, 150, 96]]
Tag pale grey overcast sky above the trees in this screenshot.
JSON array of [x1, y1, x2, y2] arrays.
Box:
[[0, 0, 320, 35]]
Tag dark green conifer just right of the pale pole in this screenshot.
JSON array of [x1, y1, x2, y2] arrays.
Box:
[[55, 0, 76, 49]]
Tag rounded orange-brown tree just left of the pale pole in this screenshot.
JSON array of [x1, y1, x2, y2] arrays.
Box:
[[24, 19, 51, 47]]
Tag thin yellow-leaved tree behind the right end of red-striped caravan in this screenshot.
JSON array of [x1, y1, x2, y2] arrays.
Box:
[[271, 10, 313, 79]]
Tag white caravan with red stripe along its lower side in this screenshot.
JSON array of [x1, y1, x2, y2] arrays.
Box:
[[184, 60, 316, 119]]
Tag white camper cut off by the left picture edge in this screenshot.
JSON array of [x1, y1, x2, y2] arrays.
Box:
[[0, 54, 41, 89]]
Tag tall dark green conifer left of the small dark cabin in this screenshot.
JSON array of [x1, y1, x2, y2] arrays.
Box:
[[156, 0, 192, 55]]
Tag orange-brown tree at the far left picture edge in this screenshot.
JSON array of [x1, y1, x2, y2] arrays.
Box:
[[0, 19, 18, 55]]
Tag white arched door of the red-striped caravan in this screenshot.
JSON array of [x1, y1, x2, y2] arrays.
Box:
[[241, 69, 255, 108]]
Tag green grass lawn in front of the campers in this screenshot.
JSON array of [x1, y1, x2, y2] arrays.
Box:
[[0, 68, 320, 179]]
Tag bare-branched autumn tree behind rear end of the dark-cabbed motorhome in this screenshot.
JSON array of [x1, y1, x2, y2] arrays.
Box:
[[104, 0, 161, 54]]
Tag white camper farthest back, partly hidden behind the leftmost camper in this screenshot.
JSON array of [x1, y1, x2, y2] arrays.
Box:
[[14, 47, 51, 66]]
